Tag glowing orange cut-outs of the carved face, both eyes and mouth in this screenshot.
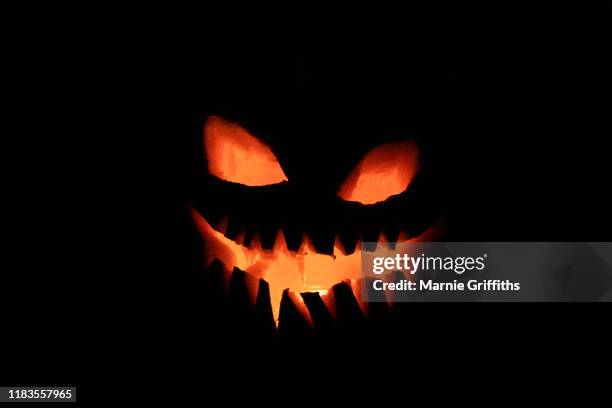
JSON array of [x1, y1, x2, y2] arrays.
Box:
[[192, 116, 437, 319]]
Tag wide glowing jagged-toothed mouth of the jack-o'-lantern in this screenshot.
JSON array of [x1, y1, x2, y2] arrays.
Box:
[[191, 207, 439, 323]]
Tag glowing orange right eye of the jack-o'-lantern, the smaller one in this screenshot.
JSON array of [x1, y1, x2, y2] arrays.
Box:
[[338, 141, 419, 204]]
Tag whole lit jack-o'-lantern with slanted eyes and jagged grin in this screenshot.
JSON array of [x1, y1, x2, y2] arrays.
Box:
[[186, 47, 440, 334]]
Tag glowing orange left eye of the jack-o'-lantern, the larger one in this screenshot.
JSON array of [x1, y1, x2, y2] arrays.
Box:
[[204, 116, 287, 186]]
